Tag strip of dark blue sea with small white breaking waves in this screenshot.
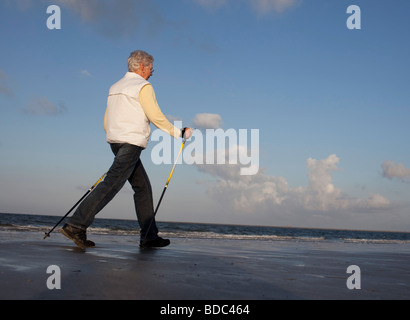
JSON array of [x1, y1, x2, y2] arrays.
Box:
[[0, 213, 410, 244]]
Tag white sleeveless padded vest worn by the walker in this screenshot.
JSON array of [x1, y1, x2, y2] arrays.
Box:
[[106, 72, 151, 148]]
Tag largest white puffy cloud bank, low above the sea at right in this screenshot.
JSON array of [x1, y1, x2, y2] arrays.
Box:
[[197, 154, 390, 216]]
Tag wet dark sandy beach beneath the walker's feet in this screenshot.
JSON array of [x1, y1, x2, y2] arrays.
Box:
[[0, 231, 410, 301]]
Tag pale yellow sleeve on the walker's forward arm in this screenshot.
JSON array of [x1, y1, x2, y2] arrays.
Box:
[[139, 84, 181, 138]]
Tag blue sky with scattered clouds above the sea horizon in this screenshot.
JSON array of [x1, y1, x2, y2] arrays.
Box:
[[0, 0, 410, 231]]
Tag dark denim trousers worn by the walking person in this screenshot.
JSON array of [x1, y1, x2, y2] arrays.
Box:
[[67, 143, 158, 240]]
